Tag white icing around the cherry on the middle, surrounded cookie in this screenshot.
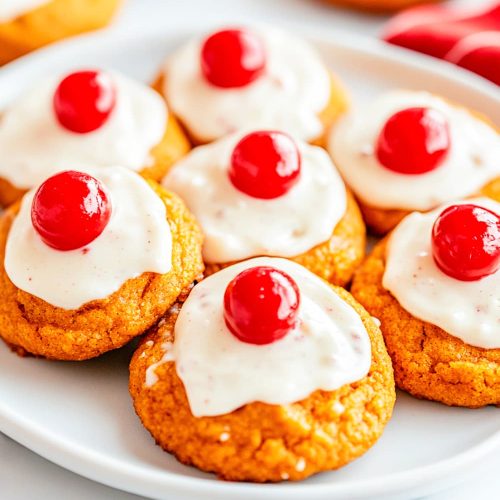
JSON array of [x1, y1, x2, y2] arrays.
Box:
[[163, 134, 346, 262]]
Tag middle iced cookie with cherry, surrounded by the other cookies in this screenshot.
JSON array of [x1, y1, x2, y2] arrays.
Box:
[[163, 130, 365, 285]]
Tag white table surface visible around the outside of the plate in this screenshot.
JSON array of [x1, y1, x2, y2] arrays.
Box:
[[0, 0, 500, 500]]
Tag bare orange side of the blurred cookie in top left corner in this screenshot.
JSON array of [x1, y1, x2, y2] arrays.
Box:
[[0, 0, 121, 65]]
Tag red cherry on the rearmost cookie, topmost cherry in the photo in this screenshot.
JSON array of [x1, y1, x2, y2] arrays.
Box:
[[201, 29, 266, 88]]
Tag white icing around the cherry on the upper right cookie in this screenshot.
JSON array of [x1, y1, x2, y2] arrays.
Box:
[[329, 90, 500, 210]]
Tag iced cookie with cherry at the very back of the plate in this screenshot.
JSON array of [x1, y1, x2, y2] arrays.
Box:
[[155, 26, 348, 145]]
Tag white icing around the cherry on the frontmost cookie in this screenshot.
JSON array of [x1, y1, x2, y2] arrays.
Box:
[[168, 257, 371, 417]]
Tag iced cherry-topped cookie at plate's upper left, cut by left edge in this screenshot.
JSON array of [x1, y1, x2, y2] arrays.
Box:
[[0, 70, 190, 206]]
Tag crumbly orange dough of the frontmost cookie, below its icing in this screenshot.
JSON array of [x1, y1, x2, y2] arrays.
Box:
[[130, 287, 395, 482]]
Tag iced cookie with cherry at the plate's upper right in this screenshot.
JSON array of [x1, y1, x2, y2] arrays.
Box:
[[328, 90, 500, 234]]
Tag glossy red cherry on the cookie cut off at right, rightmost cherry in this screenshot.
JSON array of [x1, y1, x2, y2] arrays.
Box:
[[432, 204, 500, 281]]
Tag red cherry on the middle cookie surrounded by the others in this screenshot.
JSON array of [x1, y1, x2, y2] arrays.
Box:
[[228, 132, 301, 199]]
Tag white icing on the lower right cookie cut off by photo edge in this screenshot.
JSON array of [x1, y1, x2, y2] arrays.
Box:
[[383, 198, 500, 349]]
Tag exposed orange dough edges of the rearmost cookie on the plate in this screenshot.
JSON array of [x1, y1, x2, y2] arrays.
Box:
[[152, 74, 349, 147]]
